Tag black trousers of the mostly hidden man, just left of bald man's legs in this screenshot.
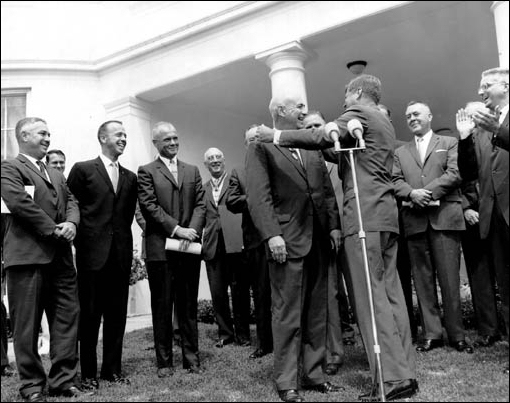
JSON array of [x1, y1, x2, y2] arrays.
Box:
[[244, 244, 273, 352]]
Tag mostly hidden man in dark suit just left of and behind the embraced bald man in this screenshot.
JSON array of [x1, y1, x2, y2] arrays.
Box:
[[225, 126, 273, 359]]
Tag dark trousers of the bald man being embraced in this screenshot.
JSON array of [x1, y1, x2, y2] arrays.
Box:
[[269, 237, 329, 390]]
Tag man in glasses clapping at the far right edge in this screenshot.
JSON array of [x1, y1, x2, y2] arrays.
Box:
[[473, 67, 508, 151]]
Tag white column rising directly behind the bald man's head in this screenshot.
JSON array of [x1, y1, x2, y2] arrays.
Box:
[[255, 42, 315, 107]]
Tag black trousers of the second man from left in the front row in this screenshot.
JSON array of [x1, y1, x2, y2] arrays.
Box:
[[78, 244, 130, 379]]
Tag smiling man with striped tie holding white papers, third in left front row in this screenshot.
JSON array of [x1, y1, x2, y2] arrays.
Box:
[[138, 122, 205, 378]]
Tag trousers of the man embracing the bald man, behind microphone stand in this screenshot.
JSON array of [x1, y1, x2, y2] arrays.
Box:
[[344, 232, 416, 382]]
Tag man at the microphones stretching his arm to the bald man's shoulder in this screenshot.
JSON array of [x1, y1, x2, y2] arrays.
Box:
[[258, 75, 418, 401]]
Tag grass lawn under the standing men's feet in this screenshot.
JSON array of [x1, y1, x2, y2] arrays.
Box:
[[1, 323, 509, 402]]
